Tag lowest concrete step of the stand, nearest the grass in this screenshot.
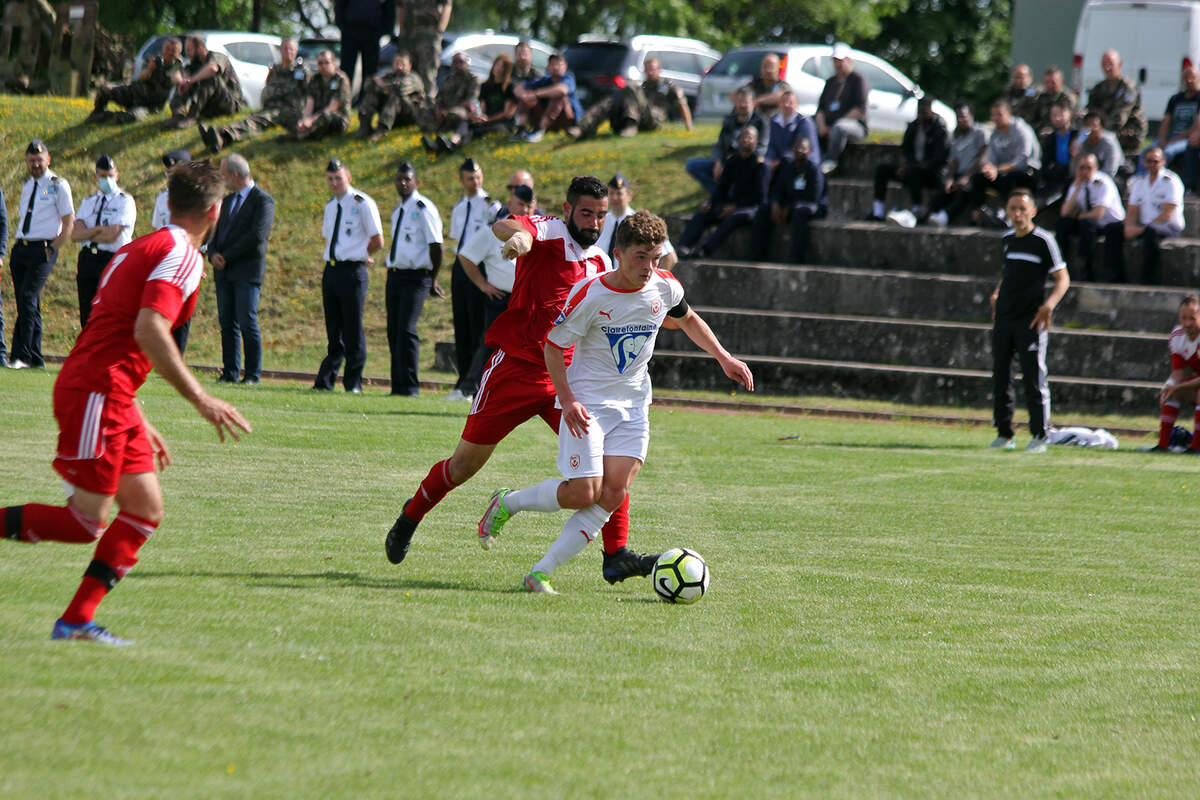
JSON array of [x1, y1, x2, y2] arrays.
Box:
[[650, 349, 1162, 412]]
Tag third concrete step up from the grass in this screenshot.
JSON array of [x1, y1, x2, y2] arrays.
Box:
[[672, 259, 1181, 333]]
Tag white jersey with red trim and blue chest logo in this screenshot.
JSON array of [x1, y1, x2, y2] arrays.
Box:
[[546, 270, 683, 409]]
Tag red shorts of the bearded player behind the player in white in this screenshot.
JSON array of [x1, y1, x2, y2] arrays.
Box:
[[462, 350, 563, 445]]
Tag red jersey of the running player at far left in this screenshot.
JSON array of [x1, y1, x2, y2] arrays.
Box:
[[55, 225, 204, 399]]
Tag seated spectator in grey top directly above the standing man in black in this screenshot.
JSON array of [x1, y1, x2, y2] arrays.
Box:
[[947, 100, 1042, 224]]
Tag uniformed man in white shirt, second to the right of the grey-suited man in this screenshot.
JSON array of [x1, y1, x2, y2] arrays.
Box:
[[386, 161, 445, 397]]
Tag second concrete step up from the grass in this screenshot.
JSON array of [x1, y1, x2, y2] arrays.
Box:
[[659, 306, 1170, 381]]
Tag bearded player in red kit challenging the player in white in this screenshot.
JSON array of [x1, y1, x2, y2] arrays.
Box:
[[384, 176, 656, 583]]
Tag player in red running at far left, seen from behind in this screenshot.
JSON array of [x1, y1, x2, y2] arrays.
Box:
[[0, 161, 250, 645]]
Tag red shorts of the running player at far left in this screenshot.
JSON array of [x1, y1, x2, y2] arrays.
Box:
[[54, 387, 154, 497]]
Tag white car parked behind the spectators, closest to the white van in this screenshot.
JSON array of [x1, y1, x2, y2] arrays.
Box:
[[696, 44, 955, 132]]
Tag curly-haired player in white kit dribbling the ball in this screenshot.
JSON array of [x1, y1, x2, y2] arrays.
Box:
[[479, 211, 754, 594]]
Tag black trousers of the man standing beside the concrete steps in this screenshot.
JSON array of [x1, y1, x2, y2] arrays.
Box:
[[991, 318, 1050, 439]]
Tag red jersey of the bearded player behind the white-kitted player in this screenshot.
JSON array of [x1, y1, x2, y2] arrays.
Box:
[[486, 216, 612, 365]]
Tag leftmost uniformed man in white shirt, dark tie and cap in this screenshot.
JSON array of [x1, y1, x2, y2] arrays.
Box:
[[8, 139, 74, 369]]
